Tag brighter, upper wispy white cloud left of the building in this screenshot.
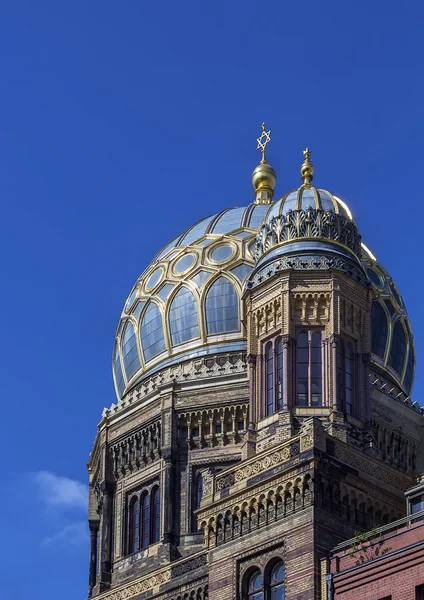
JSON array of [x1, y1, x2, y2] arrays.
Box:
[[33, 471, 88, 511]]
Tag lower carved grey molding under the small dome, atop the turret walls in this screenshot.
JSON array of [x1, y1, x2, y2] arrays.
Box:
[[246, 254, 367, 289]]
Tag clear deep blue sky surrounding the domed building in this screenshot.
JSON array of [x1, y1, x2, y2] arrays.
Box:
[[0, 0, 424, 600]]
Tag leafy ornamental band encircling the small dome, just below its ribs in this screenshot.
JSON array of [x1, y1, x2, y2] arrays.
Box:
[[255, 208, 362, 261]]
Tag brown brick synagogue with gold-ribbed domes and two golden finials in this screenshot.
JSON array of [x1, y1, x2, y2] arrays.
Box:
[[88, 124, 424, 600]]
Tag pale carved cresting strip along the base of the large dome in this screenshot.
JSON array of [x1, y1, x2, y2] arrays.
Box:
[[102, 352, 247, 418]]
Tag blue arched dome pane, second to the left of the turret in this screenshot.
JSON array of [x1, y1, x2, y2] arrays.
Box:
[[169, 287, 199, 346]]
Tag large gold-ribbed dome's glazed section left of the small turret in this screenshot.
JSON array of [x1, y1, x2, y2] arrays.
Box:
[[113, 204, 269, 396]]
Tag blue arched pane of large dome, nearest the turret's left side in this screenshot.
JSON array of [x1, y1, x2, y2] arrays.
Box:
[[206, 277, 240, 334]]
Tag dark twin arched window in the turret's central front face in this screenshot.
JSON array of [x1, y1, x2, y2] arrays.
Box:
[[296, 329, 323, 407]]
